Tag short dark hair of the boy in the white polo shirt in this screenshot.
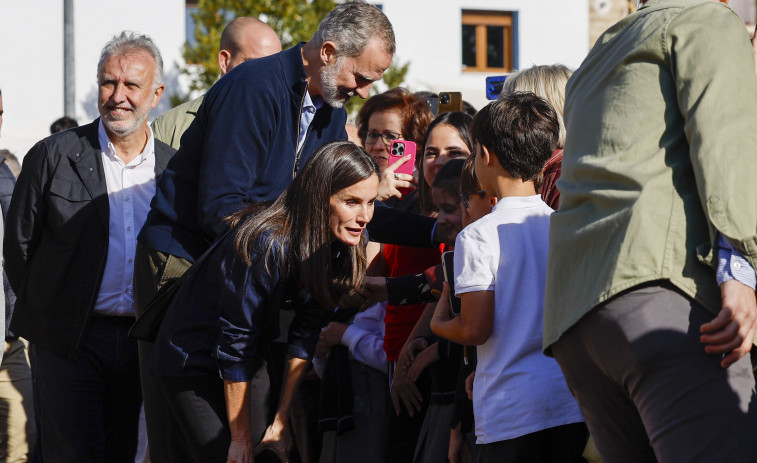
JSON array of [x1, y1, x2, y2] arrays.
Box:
[[471, 92, 560, 181]]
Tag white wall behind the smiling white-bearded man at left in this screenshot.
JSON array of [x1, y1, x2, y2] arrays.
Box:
[[0, 0, 185, 158]]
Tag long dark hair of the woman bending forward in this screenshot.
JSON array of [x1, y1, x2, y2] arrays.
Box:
[[224, 141, 379, 307]]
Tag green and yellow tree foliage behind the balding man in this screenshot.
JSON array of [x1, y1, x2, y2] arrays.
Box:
[[177, 0, 409, 115]]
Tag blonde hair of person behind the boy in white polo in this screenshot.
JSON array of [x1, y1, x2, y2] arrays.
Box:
[[499, 64, 573, 148]]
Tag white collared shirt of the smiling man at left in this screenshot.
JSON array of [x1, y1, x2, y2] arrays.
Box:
[[95, 121, 155, 316]]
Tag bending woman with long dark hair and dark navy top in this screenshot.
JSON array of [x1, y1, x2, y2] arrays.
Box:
[[154, 142, 379, 463]]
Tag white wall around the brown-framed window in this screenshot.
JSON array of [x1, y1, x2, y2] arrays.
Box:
[[376, 0, 589, 108]]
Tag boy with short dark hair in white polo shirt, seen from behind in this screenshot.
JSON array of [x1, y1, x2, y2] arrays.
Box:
[[431, 93, 587, 463]]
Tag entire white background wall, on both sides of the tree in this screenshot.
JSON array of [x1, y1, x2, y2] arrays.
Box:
[[0, 0, 589, 157]]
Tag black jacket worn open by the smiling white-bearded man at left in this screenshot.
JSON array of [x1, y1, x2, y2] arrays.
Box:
[[3, 119, 175, 357]]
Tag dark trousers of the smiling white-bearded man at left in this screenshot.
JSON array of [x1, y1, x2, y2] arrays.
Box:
[[30, 316, 142, 463]]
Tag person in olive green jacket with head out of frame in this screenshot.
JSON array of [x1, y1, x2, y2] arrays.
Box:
[[544, 0, 757, 463]]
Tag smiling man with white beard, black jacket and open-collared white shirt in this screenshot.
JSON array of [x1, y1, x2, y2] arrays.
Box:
[[4, 32, 174, 462]]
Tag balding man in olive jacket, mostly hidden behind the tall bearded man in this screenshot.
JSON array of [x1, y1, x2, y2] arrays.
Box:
[[151, 17, 281, 149]]
